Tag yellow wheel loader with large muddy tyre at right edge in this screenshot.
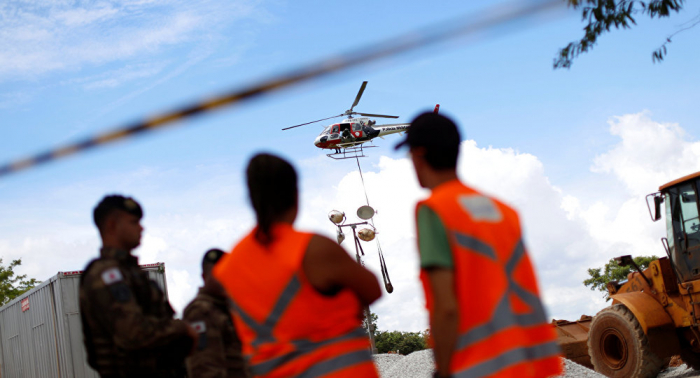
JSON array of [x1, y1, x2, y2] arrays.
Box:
[[553, 172, 700, 378]]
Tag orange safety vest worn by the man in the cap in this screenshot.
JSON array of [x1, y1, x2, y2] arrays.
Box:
[[416, 180, 562, 378]]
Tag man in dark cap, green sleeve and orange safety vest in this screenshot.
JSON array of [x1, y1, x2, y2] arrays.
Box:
[[396, 113, 563, 378]]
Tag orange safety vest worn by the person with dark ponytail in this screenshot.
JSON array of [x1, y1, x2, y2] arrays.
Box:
[[213, 224, 378, 378]]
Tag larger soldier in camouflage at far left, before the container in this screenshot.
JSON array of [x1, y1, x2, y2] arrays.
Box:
[[80, 195, 196, 378]]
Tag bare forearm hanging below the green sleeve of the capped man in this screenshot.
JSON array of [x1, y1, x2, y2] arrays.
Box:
[[427, 268, 459, 377]]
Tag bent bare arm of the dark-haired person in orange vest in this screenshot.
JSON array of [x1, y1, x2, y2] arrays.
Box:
[[302, 235, 382, 305]]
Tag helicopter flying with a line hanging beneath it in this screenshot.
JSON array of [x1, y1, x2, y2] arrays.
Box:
[[282, 81, 440, 160]]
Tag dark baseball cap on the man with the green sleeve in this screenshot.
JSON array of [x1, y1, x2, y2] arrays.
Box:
[[394, 112, 460, 152]]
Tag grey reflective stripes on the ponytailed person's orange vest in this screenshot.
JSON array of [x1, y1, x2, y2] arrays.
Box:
[[233, 275, 372, 378]]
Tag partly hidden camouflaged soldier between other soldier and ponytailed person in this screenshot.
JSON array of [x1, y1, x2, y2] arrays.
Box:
[[183, 249, 249, 378]]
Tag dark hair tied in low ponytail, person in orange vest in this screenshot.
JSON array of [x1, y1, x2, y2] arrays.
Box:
[[246, 153, 298, 244]]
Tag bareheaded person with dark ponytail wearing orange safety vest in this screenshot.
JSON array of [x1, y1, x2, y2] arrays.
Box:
[[213, 154, 381, 378]]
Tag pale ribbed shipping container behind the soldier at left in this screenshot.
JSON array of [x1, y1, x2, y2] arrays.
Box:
[[0, 263, 168, 378]]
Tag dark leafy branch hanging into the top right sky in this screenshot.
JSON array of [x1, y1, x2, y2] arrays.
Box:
[[554, 0, 694, 69]]
